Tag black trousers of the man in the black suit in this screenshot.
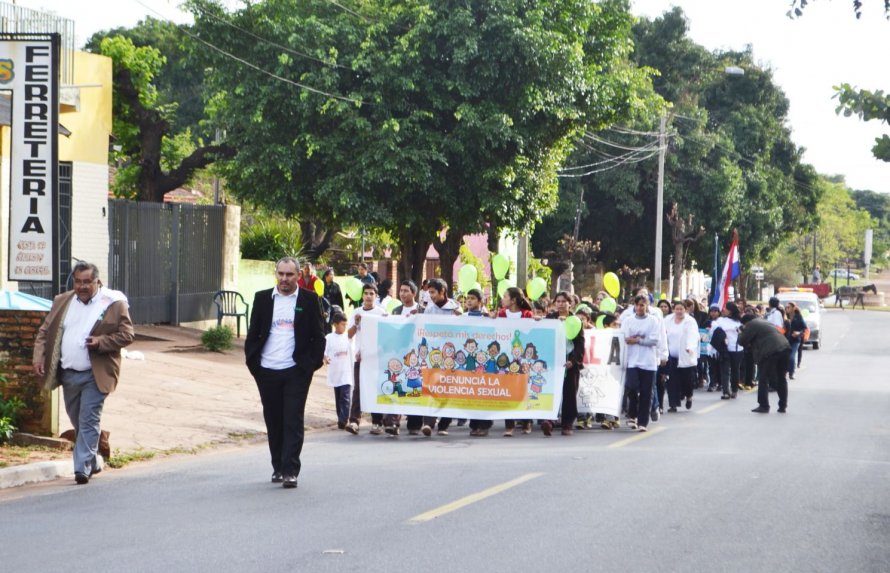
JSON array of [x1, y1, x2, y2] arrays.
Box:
[[254, 366, 312, 476]]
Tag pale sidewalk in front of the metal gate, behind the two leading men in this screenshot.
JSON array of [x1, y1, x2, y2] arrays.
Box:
[[0, 326, 337, 488]]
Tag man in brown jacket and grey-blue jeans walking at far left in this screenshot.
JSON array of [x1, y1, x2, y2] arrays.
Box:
[[32, 261, 135, 485]]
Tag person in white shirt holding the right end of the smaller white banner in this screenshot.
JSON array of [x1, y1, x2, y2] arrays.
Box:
[[621, 294, 664, 432]]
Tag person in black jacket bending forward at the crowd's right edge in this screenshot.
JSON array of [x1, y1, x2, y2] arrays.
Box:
[[739, 314, 791, 414]]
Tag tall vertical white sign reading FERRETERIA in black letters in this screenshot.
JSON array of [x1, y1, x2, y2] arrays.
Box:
[[0, 34, 61, 281]]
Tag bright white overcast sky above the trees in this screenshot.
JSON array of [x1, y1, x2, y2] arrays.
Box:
[[15, 0, 890, 193]]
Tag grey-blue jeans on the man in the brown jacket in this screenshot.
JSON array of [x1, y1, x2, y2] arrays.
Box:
[[61, 370, 108, 475]]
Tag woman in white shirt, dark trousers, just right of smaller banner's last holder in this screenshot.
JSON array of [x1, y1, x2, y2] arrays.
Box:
[[664, 300, 699, 412]]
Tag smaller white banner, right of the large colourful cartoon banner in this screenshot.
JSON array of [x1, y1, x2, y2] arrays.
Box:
[[578, 329, 627, 416]]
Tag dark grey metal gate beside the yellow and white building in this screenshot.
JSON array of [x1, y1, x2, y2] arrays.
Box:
[[108, 200, 226, 324]]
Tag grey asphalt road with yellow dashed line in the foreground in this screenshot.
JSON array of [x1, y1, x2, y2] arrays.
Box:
[[0, 311, 890, 572]]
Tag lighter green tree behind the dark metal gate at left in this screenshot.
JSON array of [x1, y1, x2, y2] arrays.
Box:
[[87, 19, 231, 202]]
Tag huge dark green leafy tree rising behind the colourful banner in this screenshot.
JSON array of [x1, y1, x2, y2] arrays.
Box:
[[190, 0, 645, 279]]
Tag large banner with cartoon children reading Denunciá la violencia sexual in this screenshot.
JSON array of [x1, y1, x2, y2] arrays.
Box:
[[360, 314, 566, 420]]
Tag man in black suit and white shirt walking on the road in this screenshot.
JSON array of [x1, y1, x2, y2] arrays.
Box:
[[244, 257, 325, 488]]
